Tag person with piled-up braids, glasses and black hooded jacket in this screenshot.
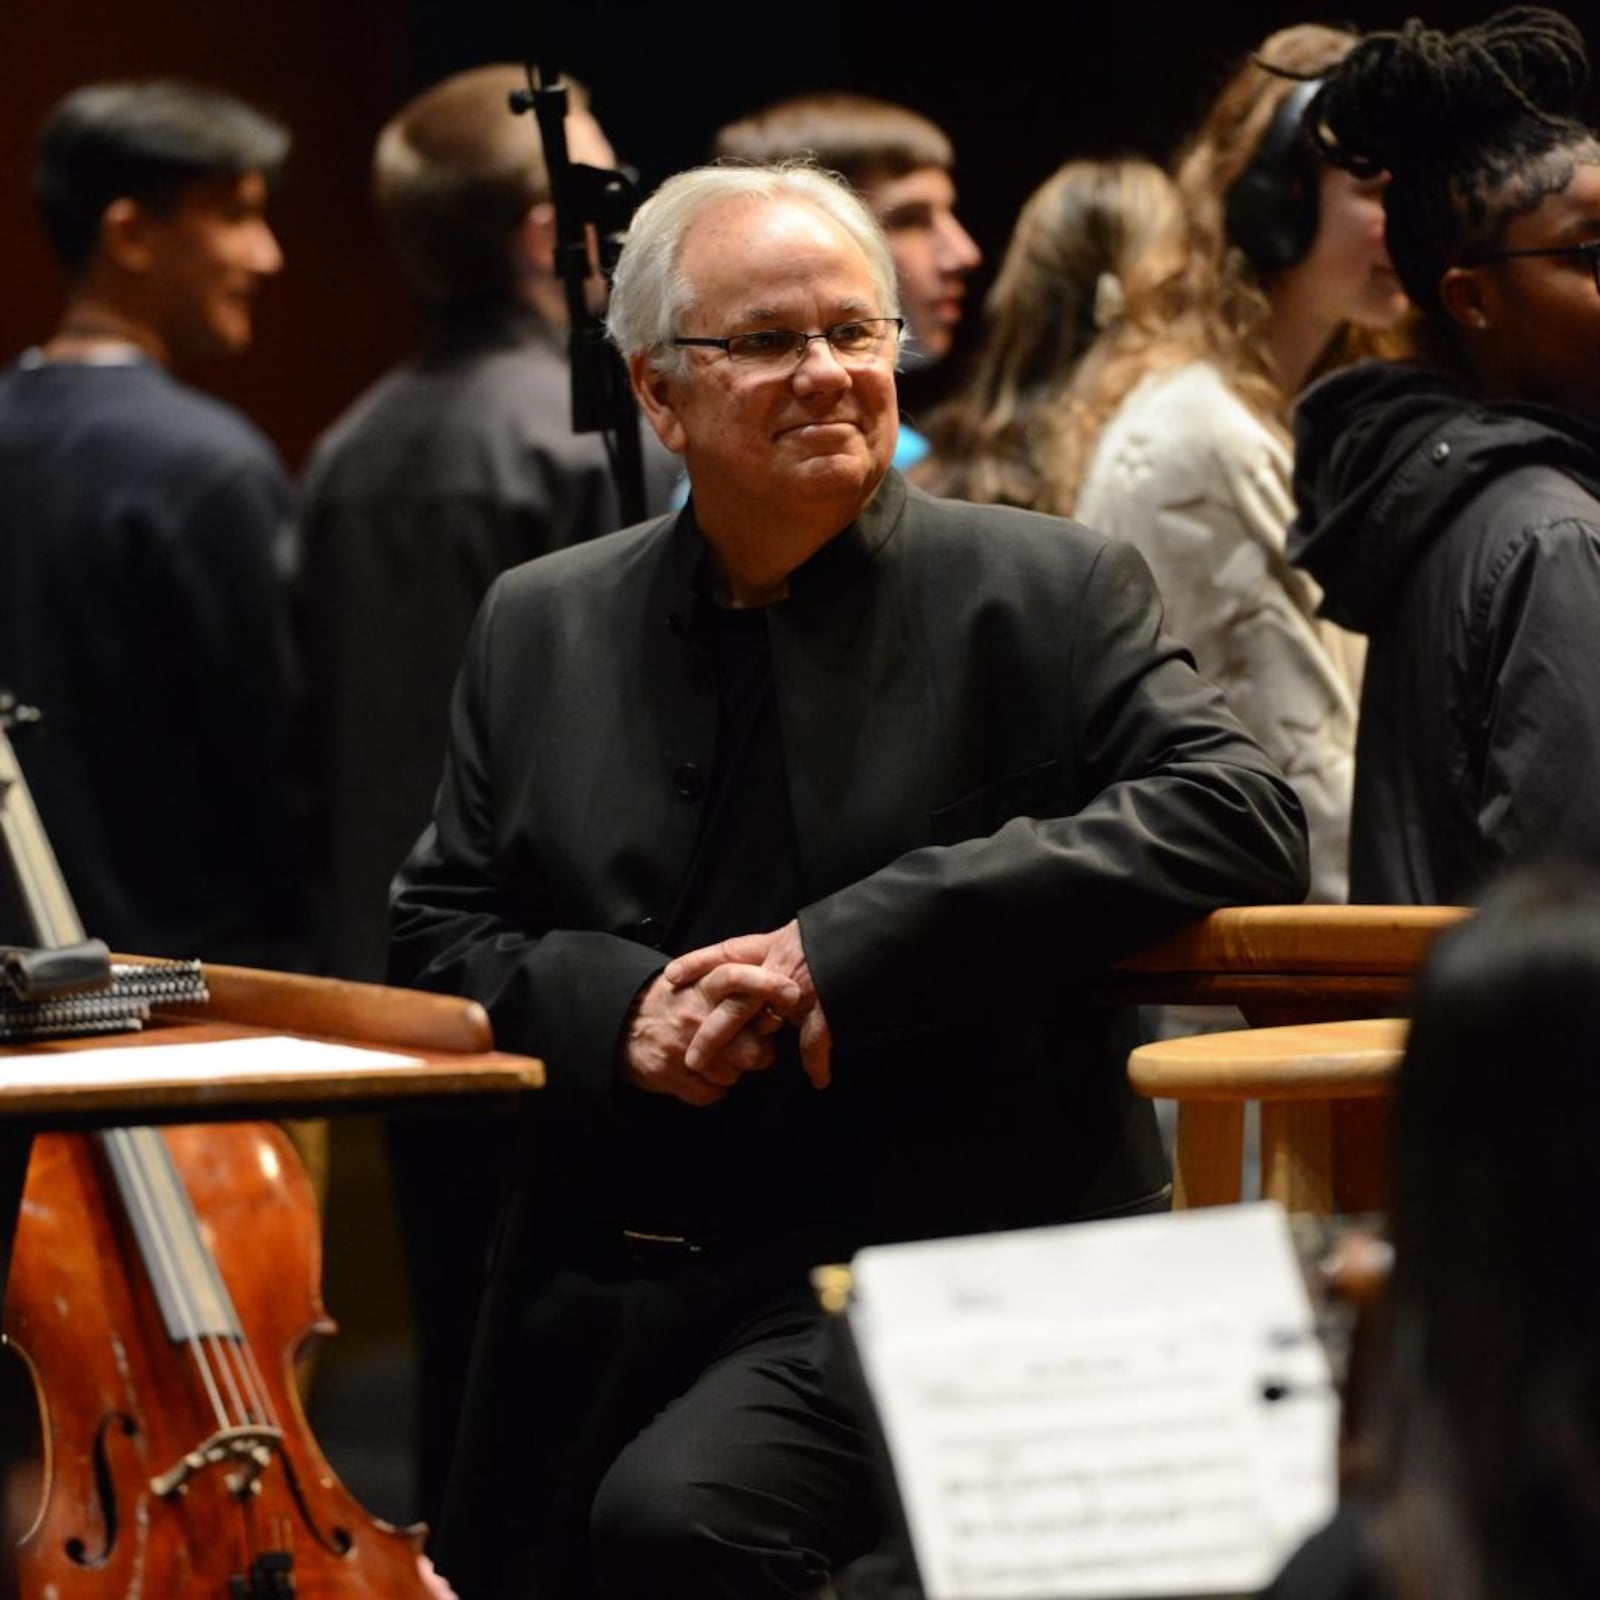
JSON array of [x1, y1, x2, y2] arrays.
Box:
[[1290, 6, 1600, 904]]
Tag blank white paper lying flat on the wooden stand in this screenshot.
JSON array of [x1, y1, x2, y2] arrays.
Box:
[[0, 1035, 426, 1090]]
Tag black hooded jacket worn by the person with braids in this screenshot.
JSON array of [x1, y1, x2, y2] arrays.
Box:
[[1290, 362, 1600, 906]]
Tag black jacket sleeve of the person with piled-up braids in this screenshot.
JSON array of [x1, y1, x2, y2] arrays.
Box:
[[1461, 518, 1600, 878]]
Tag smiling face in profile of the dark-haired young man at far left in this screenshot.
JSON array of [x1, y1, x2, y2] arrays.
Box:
[[144, 173, 283, 363]]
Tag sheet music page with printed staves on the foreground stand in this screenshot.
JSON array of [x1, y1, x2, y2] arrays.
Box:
[[850, 1203, 1338, 1600]]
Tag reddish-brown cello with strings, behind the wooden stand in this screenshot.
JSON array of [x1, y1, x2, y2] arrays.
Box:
[[0, 722, 437, 1600]]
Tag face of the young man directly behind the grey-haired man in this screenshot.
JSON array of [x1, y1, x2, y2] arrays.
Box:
[[864, 166, 982, 362]]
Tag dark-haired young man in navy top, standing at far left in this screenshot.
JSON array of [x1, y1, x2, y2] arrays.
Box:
[[0, 82, 304, 966]]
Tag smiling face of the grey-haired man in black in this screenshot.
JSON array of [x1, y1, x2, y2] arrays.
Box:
[[634, 200, 898, 536]]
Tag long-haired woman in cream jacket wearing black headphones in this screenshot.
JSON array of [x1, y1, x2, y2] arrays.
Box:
[[1046, 24, 1408, 901]]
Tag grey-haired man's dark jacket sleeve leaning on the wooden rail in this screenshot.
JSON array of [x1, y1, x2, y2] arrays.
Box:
[[800, 541, 1307, 1037]]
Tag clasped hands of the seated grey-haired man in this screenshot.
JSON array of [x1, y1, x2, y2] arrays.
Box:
[[622, 922, 834, 1106]]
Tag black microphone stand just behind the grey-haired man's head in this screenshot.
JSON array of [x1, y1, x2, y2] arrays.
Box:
[[510, 62, 645, 523]]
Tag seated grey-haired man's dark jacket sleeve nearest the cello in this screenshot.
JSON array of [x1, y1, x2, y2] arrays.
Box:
[[389, 589, 667, 1118]]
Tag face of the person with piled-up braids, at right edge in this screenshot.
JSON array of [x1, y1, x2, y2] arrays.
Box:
[[1446, 165, 1600, 421]]
